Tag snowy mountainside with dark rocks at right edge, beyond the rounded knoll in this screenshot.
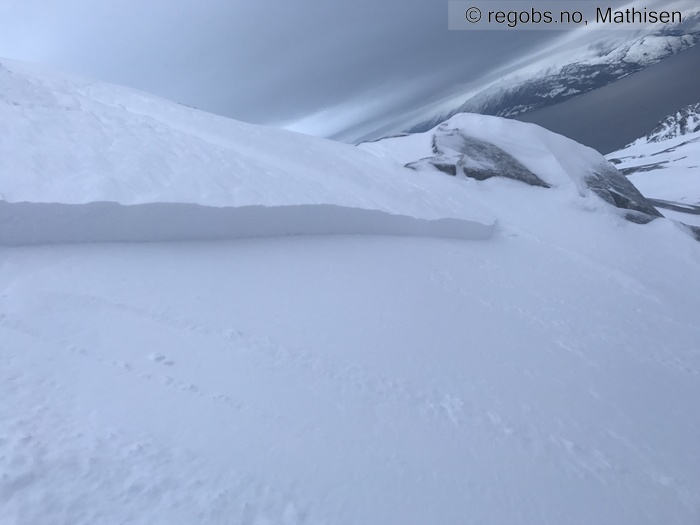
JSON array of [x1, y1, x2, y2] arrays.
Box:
[[607, 104, 700, 231]]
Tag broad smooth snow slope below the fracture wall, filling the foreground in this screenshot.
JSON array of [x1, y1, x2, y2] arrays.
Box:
[[0, 227, 700, 525]]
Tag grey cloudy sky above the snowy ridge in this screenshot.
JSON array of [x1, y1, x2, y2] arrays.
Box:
[[0, 0, 688, 141]]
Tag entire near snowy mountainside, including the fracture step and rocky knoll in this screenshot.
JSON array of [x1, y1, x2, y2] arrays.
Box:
[[0, 60, 700, 525]]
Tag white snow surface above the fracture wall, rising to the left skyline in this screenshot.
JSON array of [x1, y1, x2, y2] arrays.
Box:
[[0, 60, 492, 222]]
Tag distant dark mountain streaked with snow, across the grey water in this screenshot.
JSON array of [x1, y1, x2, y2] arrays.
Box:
[[408, 18, 700, 132]]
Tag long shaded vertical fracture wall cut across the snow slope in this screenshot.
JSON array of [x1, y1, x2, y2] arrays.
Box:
[[0, 201, 495, 246]]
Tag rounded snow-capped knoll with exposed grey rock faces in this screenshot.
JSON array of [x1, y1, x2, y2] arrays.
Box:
[[360, 113, 661, 223]]
